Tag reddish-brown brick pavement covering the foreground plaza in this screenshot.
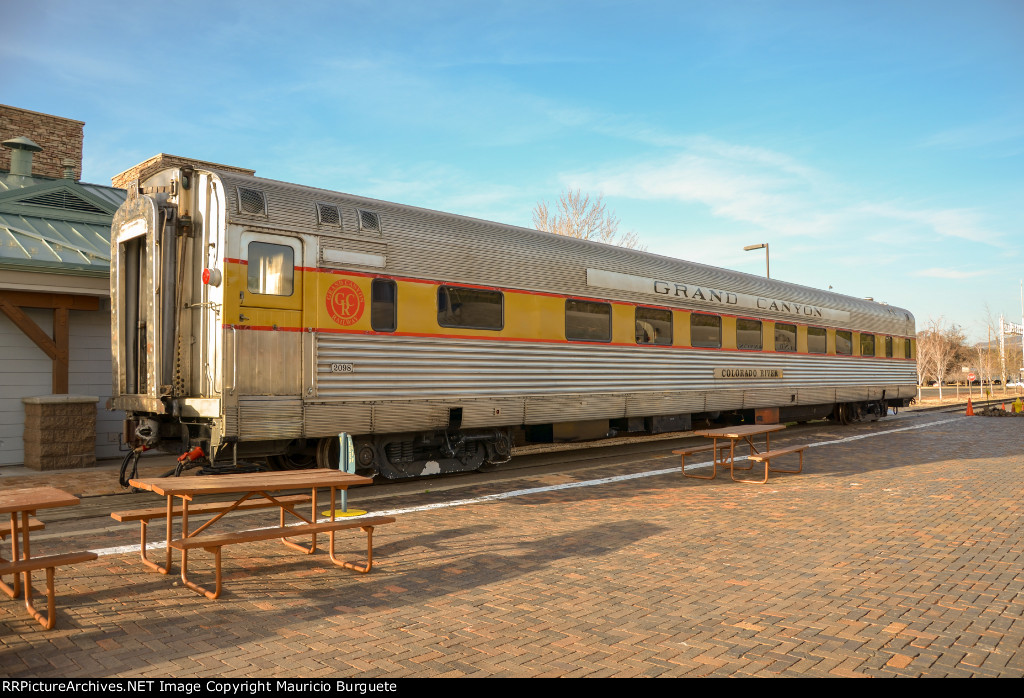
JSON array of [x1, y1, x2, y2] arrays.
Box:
[[0, 416, 1024, 678]]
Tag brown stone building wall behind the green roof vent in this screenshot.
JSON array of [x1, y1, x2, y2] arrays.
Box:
[[0, 104, 85, 180]]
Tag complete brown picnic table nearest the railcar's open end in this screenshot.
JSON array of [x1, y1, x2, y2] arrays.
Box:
[[129, 469, 394, 599]]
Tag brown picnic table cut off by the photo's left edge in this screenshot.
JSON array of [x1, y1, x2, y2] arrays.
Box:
[[0, 487, 97, 629]]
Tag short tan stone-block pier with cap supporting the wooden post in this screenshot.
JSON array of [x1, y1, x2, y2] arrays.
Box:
[[22, 395, 99, 470]]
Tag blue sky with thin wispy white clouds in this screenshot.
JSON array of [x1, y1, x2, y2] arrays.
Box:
[[0, 0, 1024, 339]]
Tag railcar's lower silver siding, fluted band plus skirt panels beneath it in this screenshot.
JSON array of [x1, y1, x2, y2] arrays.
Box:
[[306, 335, 915, 435]]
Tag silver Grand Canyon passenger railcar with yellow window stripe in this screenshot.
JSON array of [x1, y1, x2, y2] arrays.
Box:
[[111, 166, 916, 478]]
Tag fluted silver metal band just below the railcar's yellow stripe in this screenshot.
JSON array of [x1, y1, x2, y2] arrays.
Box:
[[316, 335, 916, 399]]
